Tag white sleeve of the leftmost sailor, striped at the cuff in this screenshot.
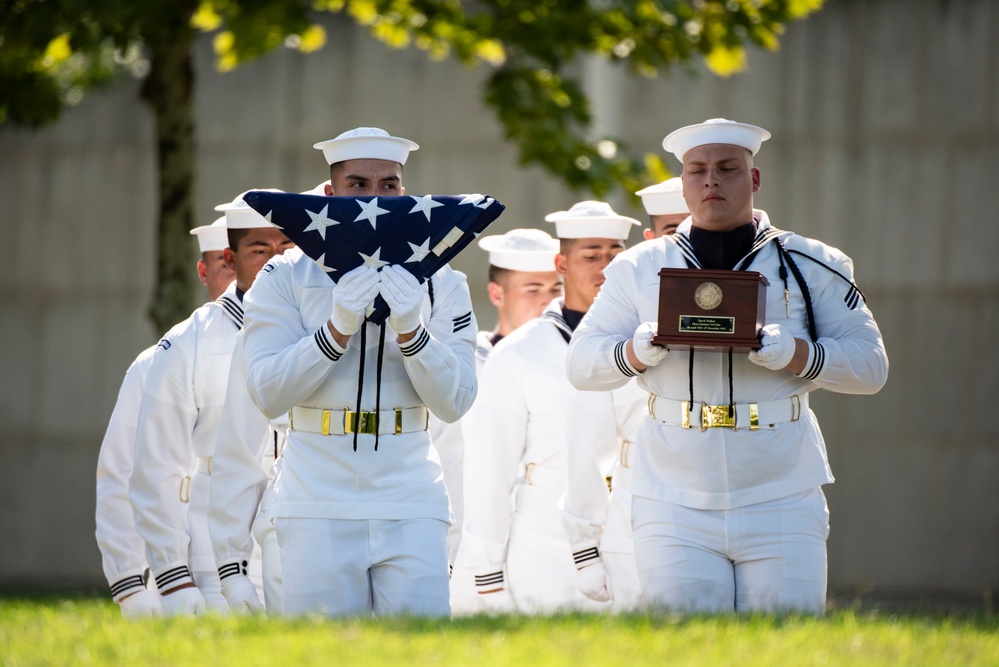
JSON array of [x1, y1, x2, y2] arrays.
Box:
[[95, 348, 154, 602]]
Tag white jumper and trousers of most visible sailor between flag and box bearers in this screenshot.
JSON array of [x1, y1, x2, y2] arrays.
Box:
[[459, 299, 614, 613]]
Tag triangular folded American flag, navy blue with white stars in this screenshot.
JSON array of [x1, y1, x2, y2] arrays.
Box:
[[243, 190, 505, 324]]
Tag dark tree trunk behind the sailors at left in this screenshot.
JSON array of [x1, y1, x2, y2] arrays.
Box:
[[142, 39, 197, 332]]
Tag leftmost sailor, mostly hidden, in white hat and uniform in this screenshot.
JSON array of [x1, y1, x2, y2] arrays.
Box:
[[95, 218, 236, 618]]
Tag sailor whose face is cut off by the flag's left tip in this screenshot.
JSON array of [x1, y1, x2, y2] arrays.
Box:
[[129, 198, 292, 615]]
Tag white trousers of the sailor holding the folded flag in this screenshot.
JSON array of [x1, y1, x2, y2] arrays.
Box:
[[276, 518, 451, 616]]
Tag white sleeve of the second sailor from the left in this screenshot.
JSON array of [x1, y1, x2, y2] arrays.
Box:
[[129, 328, 198, 585]]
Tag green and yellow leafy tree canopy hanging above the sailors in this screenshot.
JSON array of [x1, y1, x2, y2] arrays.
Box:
[[0, 0, 822, 196]]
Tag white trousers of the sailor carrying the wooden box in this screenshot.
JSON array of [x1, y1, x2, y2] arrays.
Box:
[[632, 487, 829, 614]]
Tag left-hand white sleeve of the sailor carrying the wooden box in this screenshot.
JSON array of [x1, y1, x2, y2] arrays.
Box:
[[566, 261, 642, 390]]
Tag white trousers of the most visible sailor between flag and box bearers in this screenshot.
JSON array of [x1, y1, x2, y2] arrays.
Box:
[[506, 484, 609, 614]]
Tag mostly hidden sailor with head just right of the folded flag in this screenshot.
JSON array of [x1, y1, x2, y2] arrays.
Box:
[[448, 229, 562, 615]]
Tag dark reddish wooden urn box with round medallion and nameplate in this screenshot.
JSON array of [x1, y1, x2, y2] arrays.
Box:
[[652, 269, 770, 351]]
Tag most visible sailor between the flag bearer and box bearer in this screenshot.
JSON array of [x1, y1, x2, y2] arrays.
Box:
[[461, 201, 639, 613]]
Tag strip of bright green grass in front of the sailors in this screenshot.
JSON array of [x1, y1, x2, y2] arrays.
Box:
[[0, 597, 999, 667]]
